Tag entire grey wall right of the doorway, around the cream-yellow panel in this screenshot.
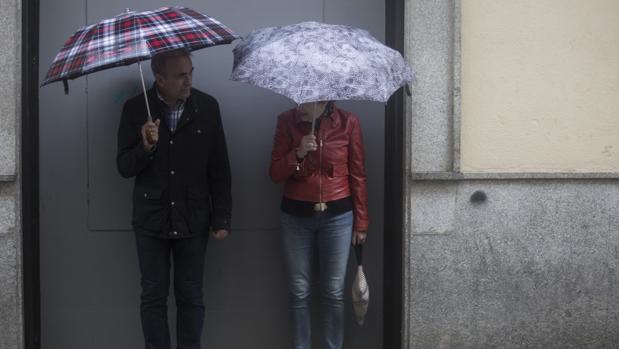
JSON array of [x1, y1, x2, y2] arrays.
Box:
[[403, 0, 619, 349]]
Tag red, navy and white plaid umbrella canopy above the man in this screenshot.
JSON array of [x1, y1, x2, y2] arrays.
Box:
[[41, 7, 239, 89]]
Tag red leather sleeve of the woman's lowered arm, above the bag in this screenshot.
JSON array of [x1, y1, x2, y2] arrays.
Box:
[[348, 118, 370, 231]]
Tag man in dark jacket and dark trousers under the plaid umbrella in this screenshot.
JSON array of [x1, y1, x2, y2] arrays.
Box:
[[116, 50, 231, 349]]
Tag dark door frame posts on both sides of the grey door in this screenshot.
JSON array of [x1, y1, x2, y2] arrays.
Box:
[[20, 0, 406, 349]]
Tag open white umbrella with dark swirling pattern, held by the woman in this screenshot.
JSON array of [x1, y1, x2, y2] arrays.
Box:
[[231, 22, 412, 104]]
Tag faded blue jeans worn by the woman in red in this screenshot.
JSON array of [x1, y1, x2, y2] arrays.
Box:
[[281, 211, 353, 349]]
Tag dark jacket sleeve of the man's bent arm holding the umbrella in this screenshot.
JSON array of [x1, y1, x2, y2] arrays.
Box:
[[116, 103, 155, 178]]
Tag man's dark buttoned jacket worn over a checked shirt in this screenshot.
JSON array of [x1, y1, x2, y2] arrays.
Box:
[[116, 87, 231, 238]]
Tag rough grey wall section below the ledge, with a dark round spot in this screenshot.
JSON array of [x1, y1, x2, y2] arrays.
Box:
[[407, 180, 619, 348]]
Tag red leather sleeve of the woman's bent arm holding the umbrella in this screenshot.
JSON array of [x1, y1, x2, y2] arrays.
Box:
[[269, 114, 300, 183]]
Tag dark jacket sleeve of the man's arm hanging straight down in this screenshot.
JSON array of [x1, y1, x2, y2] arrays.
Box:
[[208, 102, 232, 231]]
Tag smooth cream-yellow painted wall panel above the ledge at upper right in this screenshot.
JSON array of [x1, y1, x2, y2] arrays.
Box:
[[461, 0, 619, 172]]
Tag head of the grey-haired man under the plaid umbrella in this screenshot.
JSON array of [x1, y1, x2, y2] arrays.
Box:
[[155, 56, 193, 102]]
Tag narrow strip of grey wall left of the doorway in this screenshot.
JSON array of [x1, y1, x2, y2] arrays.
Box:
[[0, 0, 23, 348]]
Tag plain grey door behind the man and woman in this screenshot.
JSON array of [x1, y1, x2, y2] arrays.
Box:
[[24, 0, 403, 348]]
